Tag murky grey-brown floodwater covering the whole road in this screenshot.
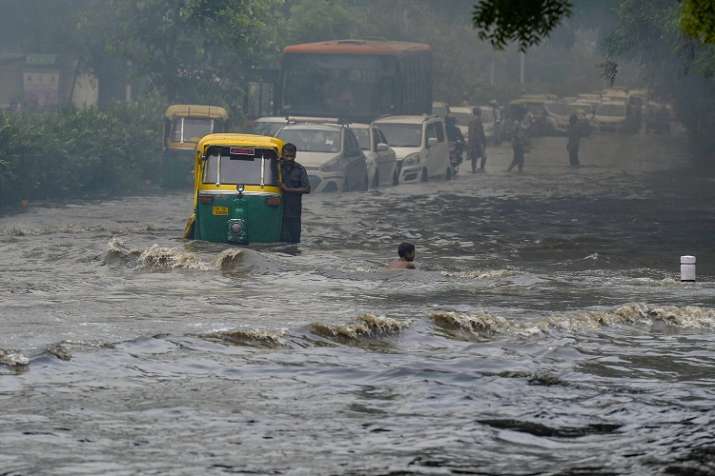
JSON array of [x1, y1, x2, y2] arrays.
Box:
[[0, 131, 715, 475]]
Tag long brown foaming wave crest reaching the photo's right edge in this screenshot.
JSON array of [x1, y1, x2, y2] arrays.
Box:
[[432, 304, 715, 339]]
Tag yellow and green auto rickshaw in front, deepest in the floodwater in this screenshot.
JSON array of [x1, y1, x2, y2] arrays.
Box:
[[184, 134, 284, 245]]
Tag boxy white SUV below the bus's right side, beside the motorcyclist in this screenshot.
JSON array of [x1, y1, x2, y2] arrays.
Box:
[[374, 115, 453, 183]]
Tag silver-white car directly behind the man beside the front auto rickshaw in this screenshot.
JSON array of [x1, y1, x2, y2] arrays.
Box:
[[276, 124, 368, 192]]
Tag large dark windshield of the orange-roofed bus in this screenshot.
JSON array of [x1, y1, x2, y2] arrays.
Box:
[[283, 54, 397, 117]]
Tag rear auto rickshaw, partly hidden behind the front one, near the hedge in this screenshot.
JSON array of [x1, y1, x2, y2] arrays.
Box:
[[161, 104, 228, 187]]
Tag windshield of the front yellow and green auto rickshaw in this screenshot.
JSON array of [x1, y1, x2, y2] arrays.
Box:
[[203, 151, 277, 185]]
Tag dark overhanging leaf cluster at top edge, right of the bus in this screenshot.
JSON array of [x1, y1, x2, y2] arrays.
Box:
[[472, 0, 573, 51]]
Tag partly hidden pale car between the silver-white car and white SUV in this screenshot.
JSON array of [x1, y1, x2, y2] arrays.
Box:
[[350, 124, 398, 188]]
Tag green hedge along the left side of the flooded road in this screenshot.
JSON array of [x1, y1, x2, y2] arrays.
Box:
[[0, 101, 163, 207]]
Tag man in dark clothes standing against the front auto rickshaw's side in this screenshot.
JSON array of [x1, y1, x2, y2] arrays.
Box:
[[281, 143, 310, 243]]
